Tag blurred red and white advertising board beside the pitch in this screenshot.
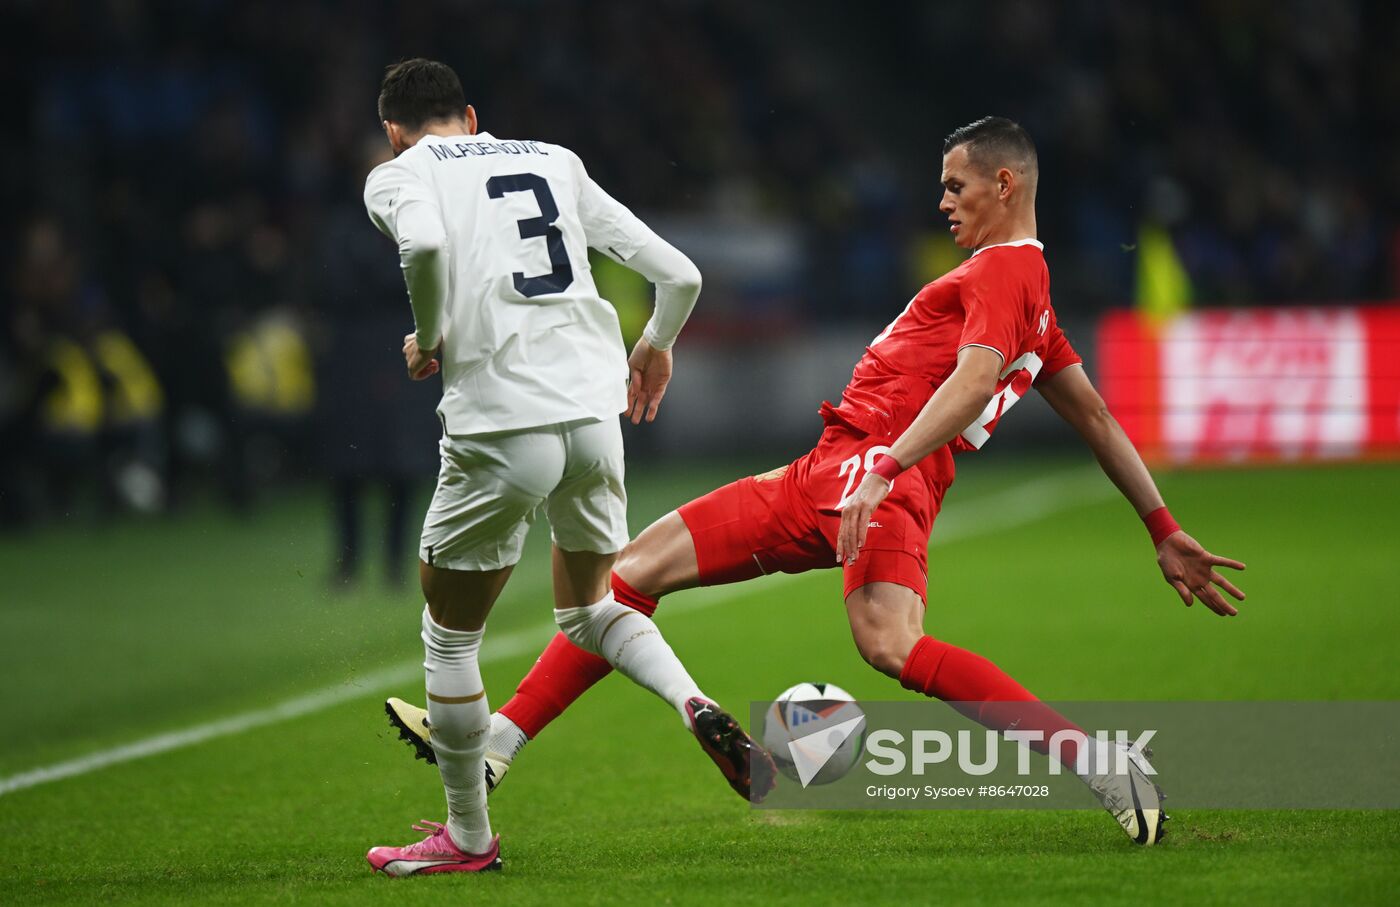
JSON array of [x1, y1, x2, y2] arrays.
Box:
[[1098, 305, 1400, 462]]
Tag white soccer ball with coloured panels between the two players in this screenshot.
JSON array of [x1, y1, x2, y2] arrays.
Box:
[[763, 683, 865, 787]]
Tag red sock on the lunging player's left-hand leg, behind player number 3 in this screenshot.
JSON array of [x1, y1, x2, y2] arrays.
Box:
[[500, 574, 657, 739]]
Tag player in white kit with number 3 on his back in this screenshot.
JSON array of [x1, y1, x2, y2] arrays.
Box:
[[355, 59, 766, 876]]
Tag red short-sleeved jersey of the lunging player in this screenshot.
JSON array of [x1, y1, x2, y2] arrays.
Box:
[[822, 239, 1082, 451]]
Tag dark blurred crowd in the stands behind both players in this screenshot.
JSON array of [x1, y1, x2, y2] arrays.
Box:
[[0, 0, 1400, 534]]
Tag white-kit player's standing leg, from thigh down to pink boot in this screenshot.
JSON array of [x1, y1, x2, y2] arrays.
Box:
[[367, 561, 512, 875]]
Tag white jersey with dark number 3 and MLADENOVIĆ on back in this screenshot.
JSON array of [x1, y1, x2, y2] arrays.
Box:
[[364, 133, 655, 435]]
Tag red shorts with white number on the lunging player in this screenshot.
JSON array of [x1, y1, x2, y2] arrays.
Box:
[[676, 426, 953, 598]]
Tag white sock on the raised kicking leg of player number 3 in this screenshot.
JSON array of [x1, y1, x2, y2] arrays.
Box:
[[554, 592, 704, 728]]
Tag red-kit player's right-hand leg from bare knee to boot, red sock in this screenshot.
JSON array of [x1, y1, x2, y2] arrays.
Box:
[[846, 582, 1166, 844]]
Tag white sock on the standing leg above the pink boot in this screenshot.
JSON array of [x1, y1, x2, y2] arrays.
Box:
[[423, 607, 491, 854]]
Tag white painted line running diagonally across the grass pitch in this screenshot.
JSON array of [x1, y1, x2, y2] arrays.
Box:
[[0, 469, 1113, 796]]
